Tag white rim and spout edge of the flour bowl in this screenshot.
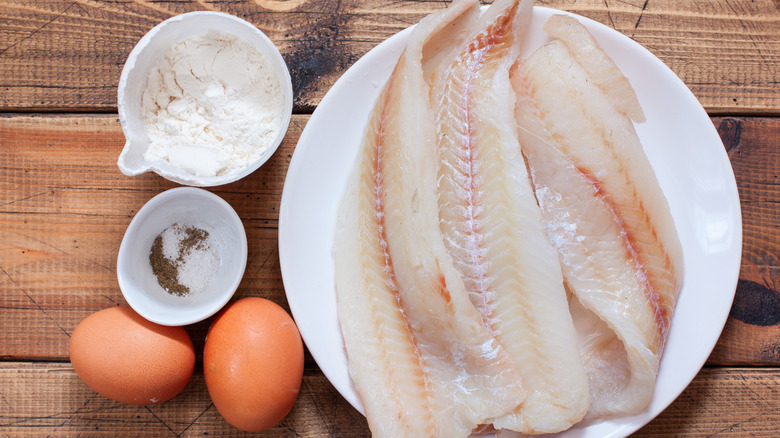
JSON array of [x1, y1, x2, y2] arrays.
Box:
[[117, 11, 294, 187]]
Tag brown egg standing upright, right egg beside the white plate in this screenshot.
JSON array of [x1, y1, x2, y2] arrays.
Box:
[[203, 297, 303, 432]]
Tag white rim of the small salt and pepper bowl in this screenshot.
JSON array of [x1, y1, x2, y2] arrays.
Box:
[[116, 187, 248, 326]]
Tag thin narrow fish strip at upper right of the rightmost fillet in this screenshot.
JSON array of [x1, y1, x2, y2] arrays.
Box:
[[544, 15, 645, 123]]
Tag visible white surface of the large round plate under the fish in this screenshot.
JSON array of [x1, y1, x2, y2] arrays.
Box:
[[279, 7, 742, 437]]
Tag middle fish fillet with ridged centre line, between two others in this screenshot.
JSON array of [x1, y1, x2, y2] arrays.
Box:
[[426, 0, 589, 433]]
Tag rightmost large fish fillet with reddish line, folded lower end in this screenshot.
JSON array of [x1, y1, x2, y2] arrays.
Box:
[[512, 33, 683, 419]]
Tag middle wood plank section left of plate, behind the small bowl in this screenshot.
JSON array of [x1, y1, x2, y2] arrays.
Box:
[[0, 116, 308, 360]]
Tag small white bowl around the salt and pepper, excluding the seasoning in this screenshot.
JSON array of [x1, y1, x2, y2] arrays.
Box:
[[116, 187, 247, 326]]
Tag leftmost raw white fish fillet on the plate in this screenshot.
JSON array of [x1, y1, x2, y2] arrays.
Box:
[[334, 1, 525, 437]]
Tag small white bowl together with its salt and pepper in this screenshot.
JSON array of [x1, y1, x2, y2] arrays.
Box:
[[116, 187, 247, 326]]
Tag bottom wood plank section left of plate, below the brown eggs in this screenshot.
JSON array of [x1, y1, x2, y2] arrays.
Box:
[[0, 362, 368, 437]]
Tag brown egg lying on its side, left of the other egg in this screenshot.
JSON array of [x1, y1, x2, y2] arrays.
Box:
[[70, 307, 195, 405]]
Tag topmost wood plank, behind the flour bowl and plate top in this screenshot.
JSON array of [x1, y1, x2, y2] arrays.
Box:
[[0, 0, 780, 115]]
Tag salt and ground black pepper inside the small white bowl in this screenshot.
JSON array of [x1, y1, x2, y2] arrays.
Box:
[[149, 223, 220, 296]]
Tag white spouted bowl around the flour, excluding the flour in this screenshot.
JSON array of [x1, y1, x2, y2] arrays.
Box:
[[117, 11, 293, 187]]
